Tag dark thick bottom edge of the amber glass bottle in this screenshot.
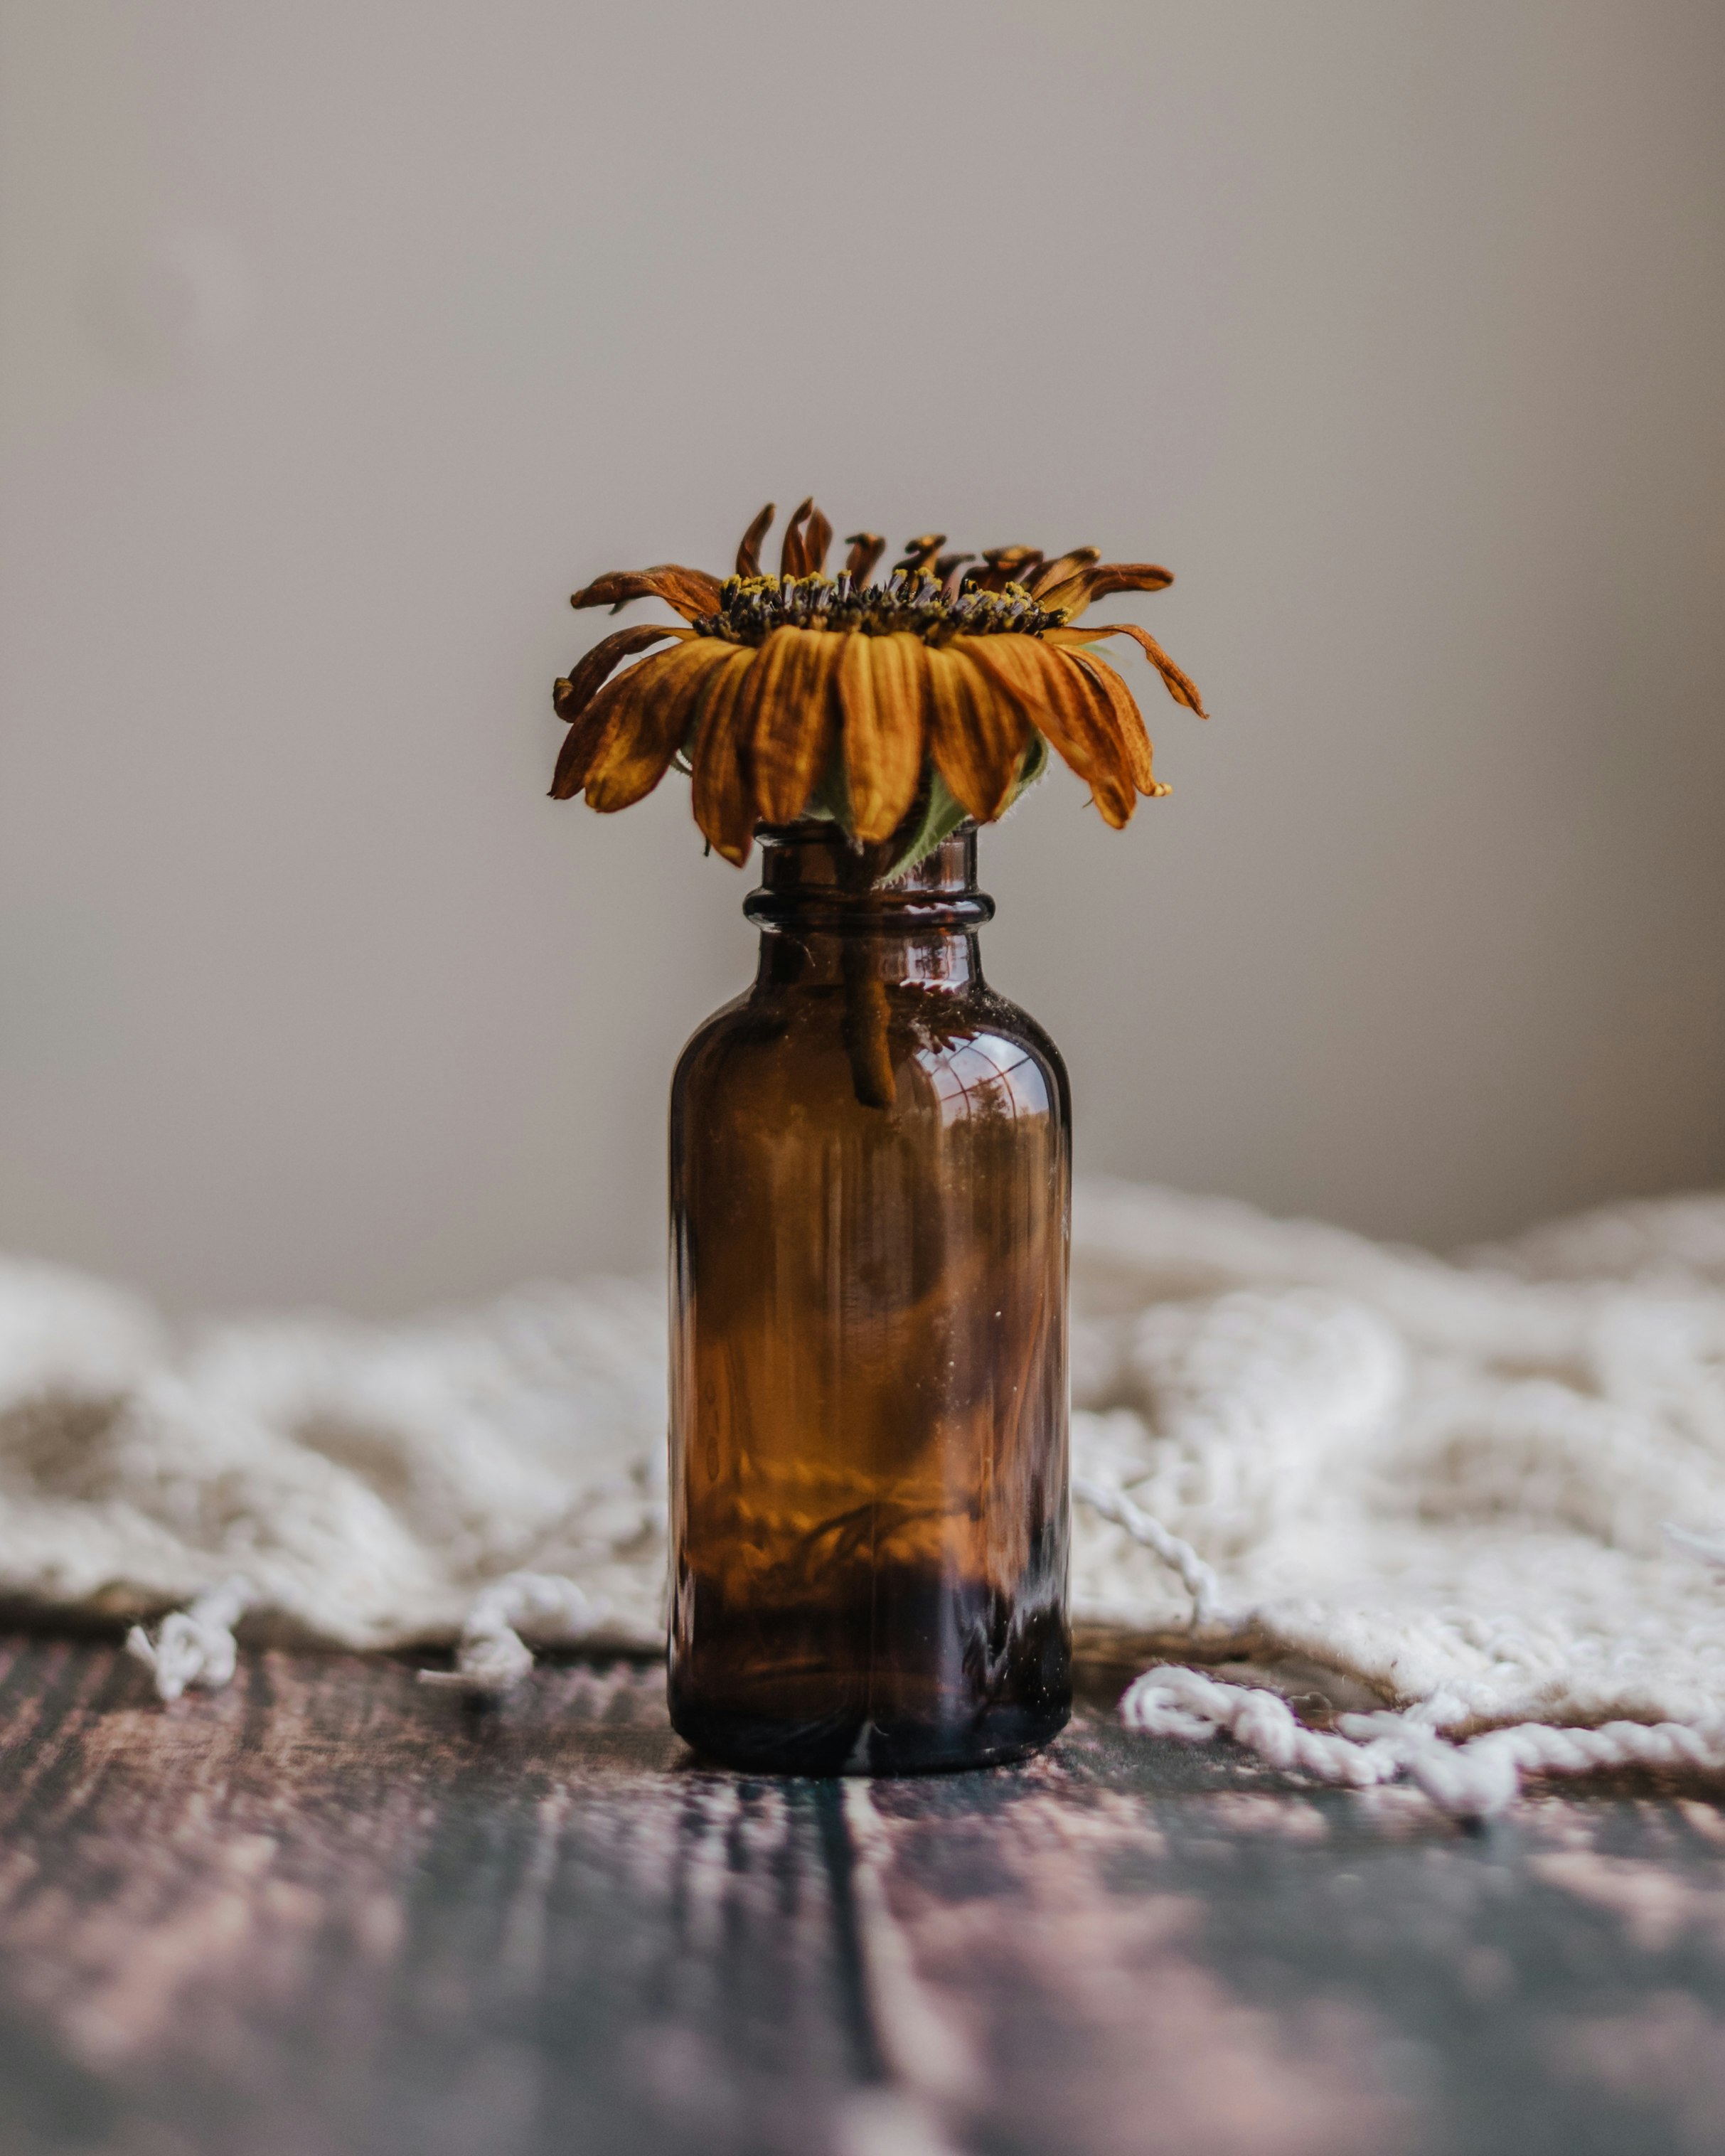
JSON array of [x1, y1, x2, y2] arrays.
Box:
[[671, 1697, 1072, 1776]]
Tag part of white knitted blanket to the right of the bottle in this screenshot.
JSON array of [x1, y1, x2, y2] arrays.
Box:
[[1074, 1186, 1725, 1731]]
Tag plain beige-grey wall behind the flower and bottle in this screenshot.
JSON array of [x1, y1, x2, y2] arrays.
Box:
[[0, 0, 1725, 1311]]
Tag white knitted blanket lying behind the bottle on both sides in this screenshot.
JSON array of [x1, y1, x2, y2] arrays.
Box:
[[0, 1184, 1725, 1781]]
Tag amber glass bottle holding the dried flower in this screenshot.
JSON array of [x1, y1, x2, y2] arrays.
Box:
[[671, 823, 1072, 1774]]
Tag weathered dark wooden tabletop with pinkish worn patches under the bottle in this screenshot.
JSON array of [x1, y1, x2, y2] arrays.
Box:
[[0, 1636, 1725, 2156]]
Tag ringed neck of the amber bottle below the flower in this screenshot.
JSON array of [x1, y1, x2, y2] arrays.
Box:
[[742, 821, 994, 990]]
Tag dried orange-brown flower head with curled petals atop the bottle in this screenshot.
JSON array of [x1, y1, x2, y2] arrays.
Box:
[[552, 500, 1203, 873]]
